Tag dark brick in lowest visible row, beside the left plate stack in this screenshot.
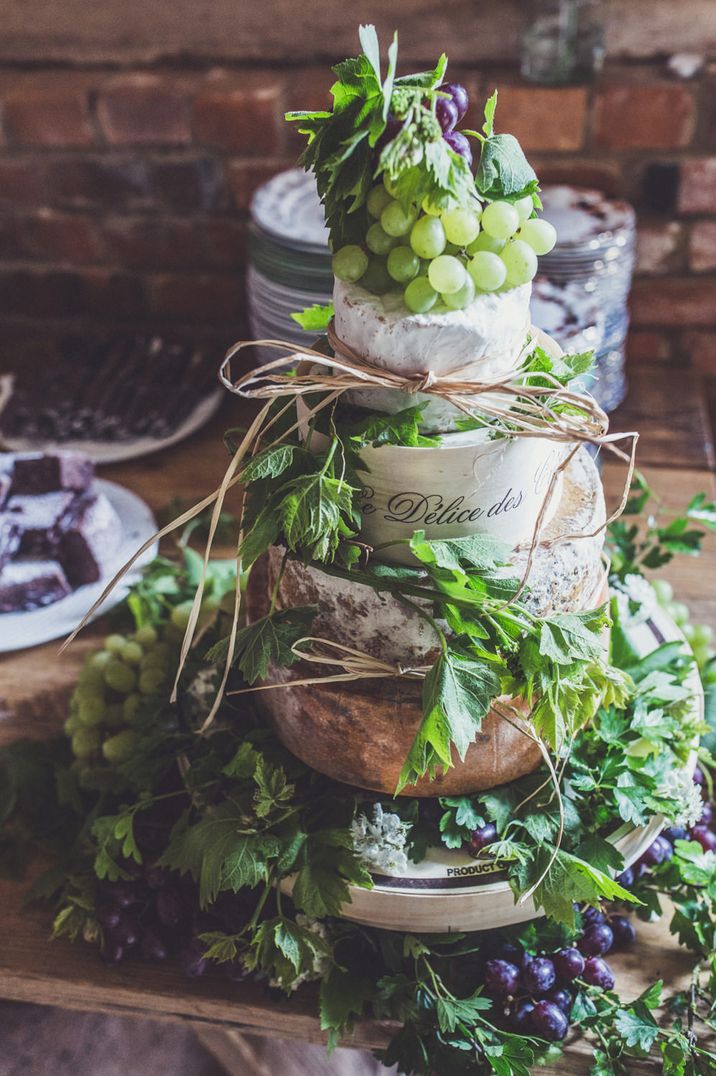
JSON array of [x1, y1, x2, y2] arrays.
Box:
[[149, 273, 243, 322]]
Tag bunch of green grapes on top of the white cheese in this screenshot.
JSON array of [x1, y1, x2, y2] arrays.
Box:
[[333, 179, 557, 314]]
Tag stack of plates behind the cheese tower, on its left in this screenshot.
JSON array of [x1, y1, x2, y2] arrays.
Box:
[[247, 168, 333, 362]]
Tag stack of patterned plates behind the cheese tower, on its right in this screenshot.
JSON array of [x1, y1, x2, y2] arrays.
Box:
[[537, 186, 636, 411]]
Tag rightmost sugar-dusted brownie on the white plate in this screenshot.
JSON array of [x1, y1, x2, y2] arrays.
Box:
[[57, 493, 122, 586]]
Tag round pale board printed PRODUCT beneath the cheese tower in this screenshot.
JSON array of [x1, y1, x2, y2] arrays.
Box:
[[281, 610, 703, 933]]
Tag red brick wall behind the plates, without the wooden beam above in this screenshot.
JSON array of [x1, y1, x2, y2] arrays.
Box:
[[0, 60, 716, 371]]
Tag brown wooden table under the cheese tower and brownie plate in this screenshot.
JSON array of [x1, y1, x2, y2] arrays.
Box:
[[0, 370, 716, 1076]]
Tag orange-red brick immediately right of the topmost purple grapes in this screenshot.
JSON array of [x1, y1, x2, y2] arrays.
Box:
[[478, 86, 587, 152]]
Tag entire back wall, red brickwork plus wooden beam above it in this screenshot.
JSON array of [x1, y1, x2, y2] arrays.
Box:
[[0, 0, 716, 372]]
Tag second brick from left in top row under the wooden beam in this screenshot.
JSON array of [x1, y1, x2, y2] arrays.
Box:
[[97, 71, 193, 145]]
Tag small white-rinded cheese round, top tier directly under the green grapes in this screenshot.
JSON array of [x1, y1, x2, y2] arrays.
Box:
[[334, 281, 532, 430]]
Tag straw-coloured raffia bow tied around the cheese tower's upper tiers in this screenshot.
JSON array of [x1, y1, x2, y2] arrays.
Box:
[[60, 322, 638, 732]]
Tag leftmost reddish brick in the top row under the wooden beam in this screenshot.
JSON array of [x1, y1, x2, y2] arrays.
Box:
[[2, 72, 95, 146]]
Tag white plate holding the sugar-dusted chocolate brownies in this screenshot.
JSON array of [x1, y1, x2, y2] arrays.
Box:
[[0, 479, 158, 653]]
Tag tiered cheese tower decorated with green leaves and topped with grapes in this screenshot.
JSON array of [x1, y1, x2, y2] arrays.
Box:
[[244, 28, 608, 796]]
